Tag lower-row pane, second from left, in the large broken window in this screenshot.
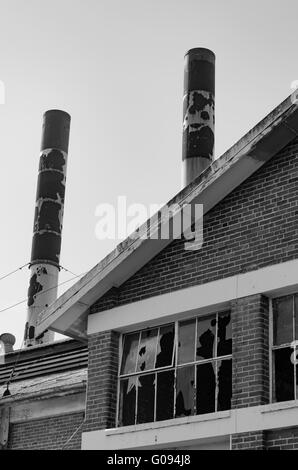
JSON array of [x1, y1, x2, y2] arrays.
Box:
[[137, 374, 155, 424]]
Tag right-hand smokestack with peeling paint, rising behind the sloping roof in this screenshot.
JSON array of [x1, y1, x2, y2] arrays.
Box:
[[182, 48, 215, 187]]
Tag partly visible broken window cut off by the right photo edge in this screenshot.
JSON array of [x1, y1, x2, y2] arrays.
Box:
[[272, 294, 298, 401]]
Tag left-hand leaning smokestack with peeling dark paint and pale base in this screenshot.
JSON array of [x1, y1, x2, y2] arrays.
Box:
[[24, 109, 70, 347]]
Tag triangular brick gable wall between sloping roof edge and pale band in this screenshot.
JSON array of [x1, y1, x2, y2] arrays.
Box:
[[91, 139, 298, 313]]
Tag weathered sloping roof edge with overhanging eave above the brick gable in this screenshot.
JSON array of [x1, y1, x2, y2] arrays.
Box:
[[37, 95, 298, 340]]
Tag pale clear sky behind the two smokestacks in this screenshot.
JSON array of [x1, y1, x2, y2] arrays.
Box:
[[0, 0, 298, 347]]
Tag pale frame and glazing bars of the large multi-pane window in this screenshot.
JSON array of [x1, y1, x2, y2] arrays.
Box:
[[116, 309, 233, 428]]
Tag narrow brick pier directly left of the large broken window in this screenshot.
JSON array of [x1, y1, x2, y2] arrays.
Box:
[[84, 331, 119, 431]]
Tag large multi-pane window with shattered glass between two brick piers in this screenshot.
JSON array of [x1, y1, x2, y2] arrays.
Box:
[[118, 312, 232, 426]]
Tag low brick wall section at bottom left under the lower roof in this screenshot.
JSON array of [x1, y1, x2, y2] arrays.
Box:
[[7, 413, 84, 450]]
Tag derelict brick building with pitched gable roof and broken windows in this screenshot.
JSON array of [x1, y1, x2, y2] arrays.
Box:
[[0, 49, 298, 450]]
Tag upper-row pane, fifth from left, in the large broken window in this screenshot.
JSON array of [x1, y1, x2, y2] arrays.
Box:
[[196, 316, 216, 360]]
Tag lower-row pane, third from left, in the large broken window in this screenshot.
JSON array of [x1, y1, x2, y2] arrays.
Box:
[[156, 370, 174, 421]]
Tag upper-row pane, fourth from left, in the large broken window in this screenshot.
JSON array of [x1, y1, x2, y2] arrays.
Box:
[[178, 320, 196, 364]]
